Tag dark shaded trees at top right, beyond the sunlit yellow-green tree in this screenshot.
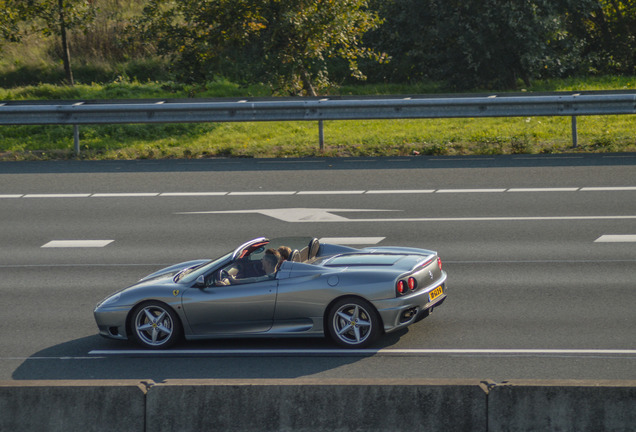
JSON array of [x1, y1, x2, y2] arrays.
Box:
[[367, 0, 636, 90]]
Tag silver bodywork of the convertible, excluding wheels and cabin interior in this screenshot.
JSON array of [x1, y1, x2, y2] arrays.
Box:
[[94, 237, 447, 339]]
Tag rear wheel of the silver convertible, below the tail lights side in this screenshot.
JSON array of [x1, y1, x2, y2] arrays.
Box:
[[325, 297, 382, 348]]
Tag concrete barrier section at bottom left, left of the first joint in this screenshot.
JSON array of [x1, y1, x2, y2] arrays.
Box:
[[0, 381, 146, 432]]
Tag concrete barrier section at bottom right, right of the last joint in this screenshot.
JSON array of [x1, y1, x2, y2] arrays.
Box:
[[488, 380, 636, 432]]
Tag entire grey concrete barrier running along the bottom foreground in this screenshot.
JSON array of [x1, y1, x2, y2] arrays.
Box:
[[0, 379, 636, 432]]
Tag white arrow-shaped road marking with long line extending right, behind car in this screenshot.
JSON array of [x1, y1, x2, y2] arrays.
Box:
[[175, 208, 636, 222]]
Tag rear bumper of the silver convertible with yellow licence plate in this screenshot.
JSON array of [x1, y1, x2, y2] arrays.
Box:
[[373, 275, 446, 333]]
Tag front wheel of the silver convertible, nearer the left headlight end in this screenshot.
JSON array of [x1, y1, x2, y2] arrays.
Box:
[[131, 301, 181, 349]]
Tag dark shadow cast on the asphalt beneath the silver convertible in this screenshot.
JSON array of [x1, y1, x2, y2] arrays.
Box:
[[12, 329, 408, 382]]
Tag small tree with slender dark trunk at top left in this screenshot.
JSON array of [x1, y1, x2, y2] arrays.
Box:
[[15, 0, 95, 85]]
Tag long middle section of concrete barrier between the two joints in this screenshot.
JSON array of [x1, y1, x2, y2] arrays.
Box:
[[146, 379, 486, 432]]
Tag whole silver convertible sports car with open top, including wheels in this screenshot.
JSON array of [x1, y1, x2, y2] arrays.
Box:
[[95, 237, 446, 349]]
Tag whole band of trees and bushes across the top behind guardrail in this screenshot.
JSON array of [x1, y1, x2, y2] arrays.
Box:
[[0, 0, 636, 95]]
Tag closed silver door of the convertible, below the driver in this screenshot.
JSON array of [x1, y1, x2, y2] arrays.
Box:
[[183, 279, 278, 335]]
